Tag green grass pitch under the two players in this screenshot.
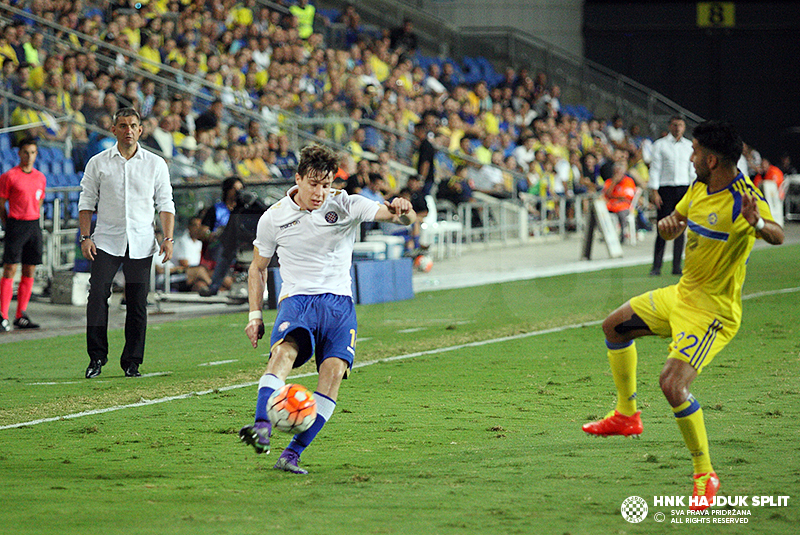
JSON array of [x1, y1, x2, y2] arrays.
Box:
[[0, 246, 800, 535]]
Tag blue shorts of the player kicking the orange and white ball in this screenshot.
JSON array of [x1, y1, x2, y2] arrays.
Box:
[[270, 294, 358, 378]]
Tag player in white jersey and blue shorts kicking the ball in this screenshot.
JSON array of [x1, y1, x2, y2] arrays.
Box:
[[239, 145, 416, 474]]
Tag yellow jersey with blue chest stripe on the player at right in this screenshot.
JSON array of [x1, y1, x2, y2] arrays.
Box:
[[675, 173, 773, 326]]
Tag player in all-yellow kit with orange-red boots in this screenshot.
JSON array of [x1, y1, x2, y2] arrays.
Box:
[[583, 121, 784, 510]]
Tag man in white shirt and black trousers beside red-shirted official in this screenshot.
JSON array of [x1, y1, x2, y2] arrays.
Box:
[[78, 108, 175, 379]]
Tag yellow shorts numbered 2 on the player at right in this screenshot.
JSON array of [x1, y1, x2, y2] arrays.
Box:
[[630, 285, 739, 373]]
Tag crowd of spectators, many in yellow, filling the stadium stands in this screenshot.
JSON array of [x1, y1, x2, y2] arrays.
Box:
[[0, 0, 792, 220]]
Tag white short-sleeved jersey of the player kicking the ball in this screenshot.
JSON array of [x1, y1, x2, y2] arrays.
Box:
[[253, 186, 381, 299]]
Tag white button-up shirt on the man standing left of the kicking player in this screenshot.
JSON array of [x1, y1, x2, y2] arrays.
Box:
[[78, 143, 175, 258]]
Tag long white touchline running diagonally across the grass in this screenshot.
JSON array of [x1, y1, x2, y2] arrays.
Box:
[[0, 287, 800, 431]]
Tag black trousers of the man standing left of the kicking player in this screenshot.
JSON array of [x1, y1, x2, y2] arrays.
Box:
[[86, 249, 153, 370]]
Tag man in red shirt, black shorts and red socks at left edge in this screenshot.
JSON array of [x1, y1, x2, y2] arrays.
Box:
[[0, 138, 47, 332]]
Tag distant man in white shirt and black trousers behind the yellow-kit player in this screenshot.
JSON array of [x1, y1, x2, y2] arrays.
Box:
[[648, 115, 697, 277]]
